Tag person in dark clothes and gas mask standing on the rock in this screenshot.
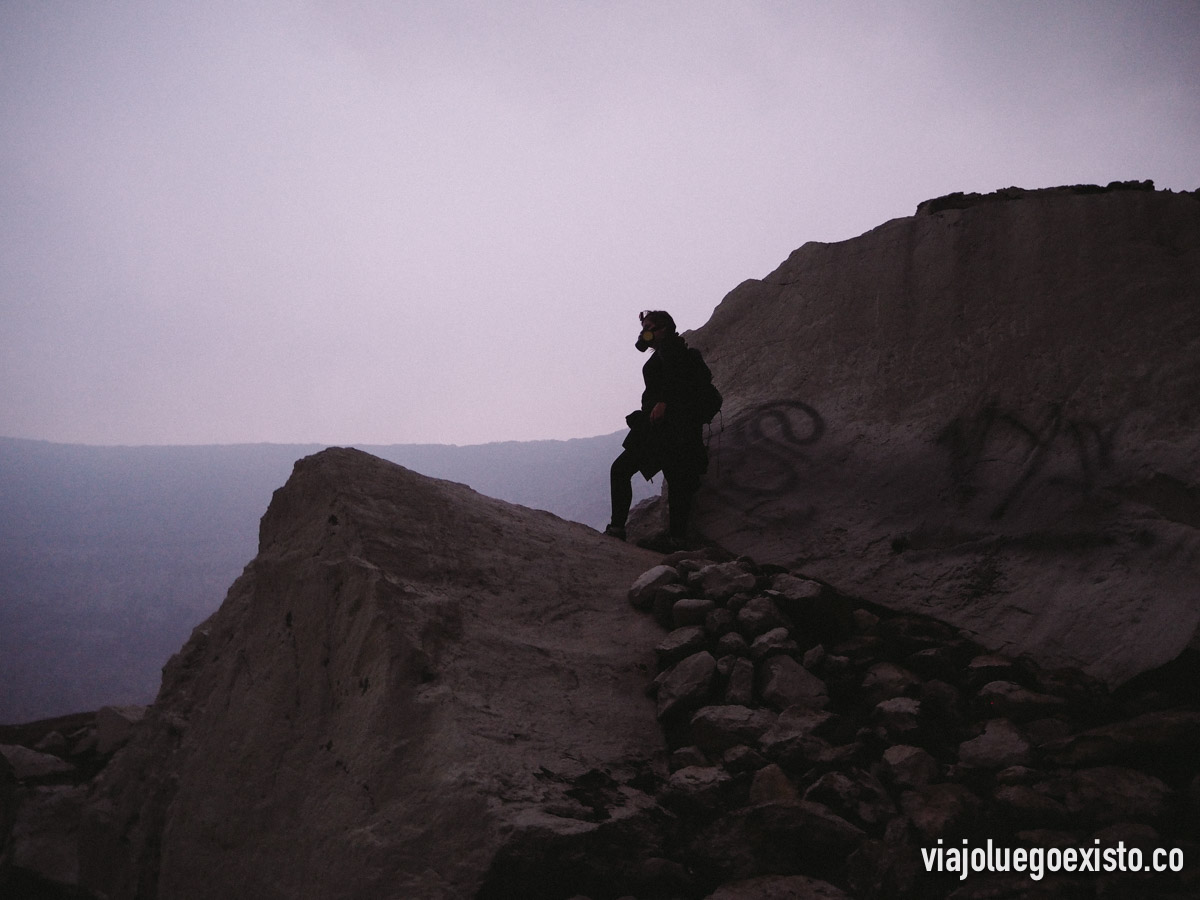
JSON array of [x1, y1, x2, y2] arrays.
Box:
[[605, 310, 720, 550]]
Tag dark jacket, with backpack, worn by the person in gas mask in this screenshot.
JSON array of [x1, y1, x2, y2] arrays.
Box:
[[624, 335, 713, 480]]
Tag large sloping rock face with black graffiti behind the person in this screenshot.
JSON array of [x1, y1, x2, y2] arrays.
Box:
[[667, 184, 1200, 685]]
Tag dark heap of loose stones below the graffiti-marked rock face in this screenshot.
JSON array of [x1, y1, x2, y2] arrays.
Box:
[[614, 554, 1200, 900]]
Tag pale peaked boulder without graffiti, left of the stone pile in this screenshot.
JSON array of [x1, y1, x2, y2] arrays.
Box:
[[65, 450, 661, 900]]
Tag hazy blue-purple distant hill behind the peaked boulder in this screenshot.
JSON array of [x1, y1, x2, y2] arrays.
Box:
[[0, 432, 660, 722]]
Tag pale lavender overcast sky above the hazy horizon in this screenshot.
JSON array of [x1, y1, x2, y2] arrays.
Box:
[[0, 0, 1200, 444]]
